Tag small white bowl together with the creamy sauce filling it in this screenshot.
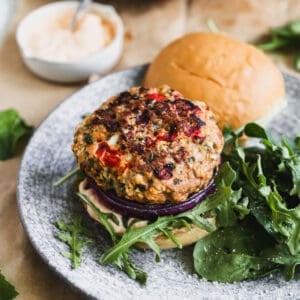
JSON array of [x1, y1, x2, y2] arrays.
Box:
[[16, 1, 124, 83]]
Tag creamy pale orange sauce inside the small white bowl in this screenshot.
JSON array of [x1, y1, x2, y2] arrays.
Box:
[[26, 9, 114, 62]]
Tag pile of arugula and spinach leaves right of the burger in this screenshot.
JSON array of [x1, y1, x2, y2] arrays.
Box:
[[194, 123, 300, 282]]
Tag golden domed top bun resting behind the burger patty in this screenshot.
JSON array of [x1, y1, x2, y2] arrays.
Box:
[[144, 32, 284, 128]]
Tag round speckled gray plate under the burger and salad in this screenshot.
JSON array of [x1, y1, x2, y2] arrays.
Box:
[[18, 66, 300, 300]]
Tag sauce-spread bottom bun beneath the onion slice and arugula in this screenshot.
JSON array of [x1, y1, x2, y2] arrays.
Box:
[[78, 180, 213, 249]]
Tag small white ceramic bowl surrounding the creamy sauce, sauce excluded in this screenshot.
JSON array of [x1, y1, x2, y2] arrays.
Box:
[[16, 1, 124, 83]]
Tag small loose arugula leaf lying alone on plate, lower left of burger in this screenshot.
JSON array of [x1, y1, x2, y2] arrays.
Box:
[[56, 216, 91, 269]]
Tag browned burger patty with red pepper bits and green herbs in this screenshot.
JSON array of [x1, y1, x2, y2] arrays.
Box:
[[72, 86, 223, 204]]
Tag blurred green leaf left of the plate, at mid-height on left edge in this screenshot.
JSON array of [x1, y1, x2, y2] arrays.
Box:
[[0, 109, 33, 160]]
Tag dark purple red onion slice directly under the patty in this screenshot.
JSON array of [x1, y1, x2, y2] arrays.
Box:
[[88, 178, 215, 220]]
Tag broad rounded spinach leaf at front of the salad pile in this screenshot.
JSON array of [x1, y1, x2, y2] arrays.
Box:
[[193, 219, 279, 282]]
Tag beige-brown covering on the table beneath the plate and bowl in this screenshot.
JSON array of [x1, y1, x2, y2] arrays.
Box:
[[0, 0, 300, 300]]
